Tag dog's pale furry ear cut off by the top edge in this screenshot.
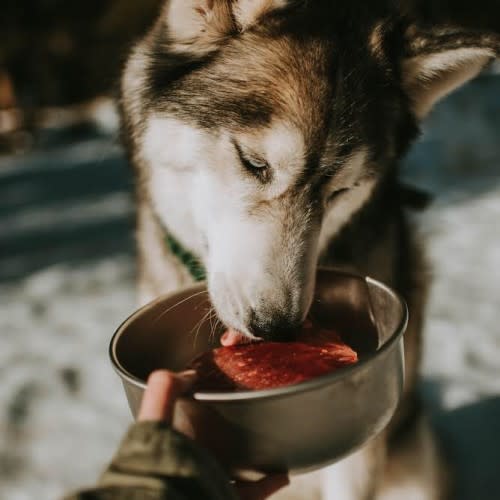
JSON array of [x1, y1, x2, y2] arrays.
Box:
[[163, 0, 297, 55]]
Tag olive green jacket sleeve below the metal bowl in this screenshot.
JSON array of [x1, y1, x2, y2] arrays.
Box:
[[65, 422, 236, 500]]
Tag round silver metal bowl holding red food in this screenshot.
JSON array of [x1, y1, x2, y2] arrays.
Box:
[[110, 269, 408, 472]]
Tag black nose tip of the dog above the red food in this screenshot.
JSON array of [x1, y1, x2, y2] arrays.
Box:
[[248, 311, 301, 342]]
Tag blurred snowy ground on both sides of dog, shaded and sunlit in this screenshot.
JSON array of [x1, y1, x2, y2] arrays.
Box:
[[0, 76, 500, 500]]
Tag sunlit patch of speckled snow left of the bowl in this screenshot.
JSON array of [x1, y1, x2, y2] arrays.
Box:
[[0, 256, 135, 500]]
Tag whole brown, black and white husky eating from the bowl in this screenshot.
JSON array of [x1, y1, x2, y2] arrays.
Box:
[[121, 0, 500, 500]]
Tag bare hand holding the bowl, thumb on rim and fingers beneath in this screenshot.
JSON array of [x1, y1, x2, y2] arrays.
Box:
[[137, 370, 289, 500]]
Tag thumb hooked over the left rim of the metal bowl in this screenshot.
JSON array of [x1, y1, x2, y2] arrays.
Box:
[[137, 370, 196, 423]]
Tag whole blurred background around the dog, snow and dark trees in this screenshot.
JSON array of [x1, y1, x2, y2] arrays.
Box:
[[0, 0, 500, 500]]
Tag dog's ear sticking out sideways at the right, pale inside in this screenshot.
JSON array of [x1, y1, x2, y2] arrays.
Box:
[[401, 24, 500, 119]]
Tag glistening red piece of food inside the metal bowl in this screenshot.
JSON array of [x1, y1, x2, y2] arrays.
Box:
[[190, 326, 358, 391]]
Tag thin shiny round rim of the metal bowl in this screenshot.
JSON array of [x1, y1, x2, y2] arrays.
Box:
[[108, 267, 408, 403]]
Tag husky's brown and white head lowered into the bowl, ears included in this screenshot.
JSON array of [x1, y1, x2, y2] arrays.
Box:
[[122, 0, 498, 336]]
